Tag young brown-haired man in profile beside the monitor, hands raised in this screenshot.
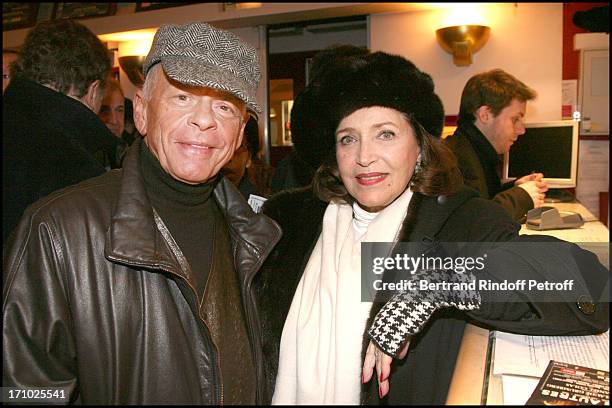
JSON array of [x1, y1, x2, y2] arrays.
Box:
[[446, 69, 548, 221]]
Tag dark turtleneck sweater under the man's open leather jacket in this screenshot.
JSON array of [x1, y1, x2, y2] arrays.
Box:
[[140, 143, 256, 404]]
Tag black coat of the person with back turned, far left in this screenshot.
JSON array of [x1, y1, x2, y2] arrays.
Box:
[[2, 78, 118, 239]]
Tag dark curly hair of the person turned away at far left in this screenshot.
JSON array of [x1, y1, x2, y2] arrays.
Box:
[[11, 20, 111, 98]]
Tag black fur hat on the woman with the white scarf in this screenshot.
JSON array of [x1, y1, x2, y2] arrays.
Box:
[[320, 52, 444, 143]]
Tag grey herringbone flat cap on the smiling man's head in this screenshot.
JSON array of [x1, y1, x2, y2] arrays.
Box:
[[143, 23, 261, 113]]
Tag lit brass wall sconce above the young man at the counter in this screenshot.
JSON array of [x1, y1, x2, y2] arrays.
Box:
[[436, 25, 491, 66]]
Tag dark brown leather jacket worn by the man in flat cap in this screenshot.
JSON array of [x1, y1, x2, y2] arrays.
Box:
[[2, 143, 281, 404]]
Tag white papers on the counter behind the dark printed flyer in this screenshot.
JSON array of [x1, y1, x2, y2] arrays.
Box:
[[493, 331, 610, 405]]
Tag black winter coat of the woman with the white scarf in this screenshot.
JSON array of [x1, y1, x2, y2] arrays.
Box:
[[254, 187, 609, 404]]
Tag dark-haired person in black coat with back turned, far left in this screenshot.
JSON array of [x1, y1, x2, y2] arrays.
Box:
[[2, 20, 117, 240]]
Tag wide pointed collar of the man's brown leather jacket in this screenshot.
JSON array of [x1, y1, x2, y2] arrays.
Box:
[[105, 139, 281, 276]]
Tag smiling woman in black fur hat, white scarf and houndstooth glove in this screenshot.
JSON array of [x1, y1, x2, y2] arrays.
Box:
[[254, 52, 608, 404]]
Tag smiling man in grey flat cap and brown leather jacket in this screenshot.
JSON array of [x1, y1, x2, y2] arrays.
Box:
[[3, 23, 280, 405]]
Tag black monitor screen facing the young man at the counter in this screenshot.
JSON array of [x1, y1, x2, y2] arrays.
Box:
[[508, 126, 573, 178]]
